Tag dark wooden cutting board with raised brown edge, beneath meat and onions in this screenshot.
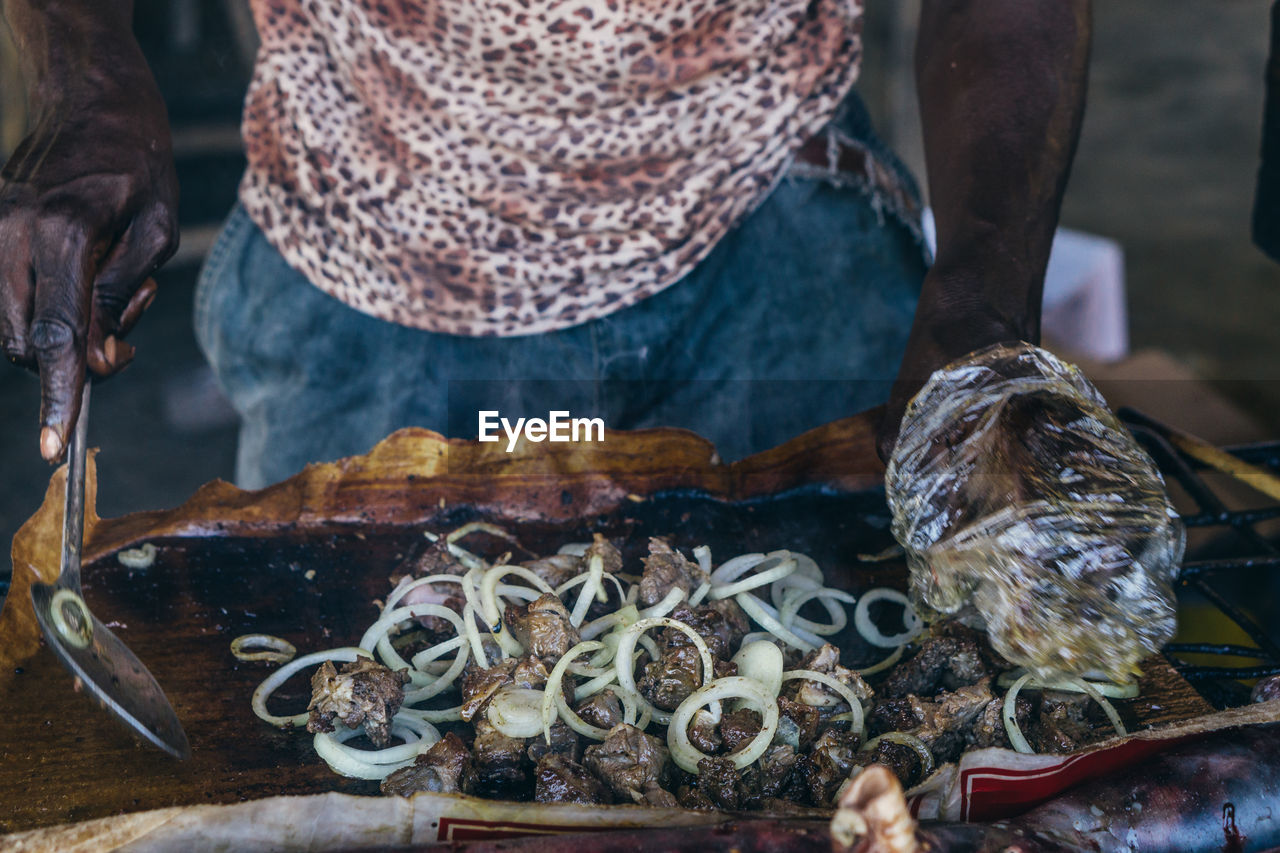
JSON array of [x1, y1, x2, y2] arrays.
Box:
[[0, 412, 1208, 833]]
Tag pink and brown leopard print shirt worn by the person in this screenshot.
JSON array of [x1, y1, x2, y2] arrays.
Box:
[[239, 0, 861, 336]]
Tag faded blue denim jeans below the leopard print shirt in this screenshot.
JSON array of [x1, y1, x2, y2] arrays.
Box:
[[196, 94, 925, 488]]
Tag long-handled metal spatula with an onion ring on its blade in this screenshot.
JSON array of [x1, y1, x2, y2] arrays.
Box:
[[31, 382, 191, 758]]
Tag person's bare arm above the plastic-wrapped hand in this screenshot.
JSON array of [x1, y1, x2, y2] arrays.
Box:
[[879, 0, 1089, 459]]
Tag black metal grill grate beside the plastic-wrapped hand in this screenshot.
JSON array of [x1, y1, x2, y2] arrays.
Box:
[[1117, 409, 1280, 706]]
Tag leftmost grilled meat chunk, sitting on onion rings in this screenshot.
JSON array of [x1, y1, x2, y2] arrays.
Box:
[[307, 657, 408, 747]]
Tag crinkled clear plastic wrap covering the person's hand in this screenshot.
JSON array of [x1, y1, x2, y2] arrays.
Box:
[[886, 343, 1185, 681]]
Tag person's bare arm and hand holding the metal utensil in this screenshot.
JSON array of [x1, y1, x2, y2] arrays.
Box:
[[0, 0, 178, 461]]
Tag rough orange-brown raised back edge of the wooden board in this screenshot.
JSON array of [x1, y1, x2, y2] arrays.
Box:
[[0, 407, 884, 689]]
